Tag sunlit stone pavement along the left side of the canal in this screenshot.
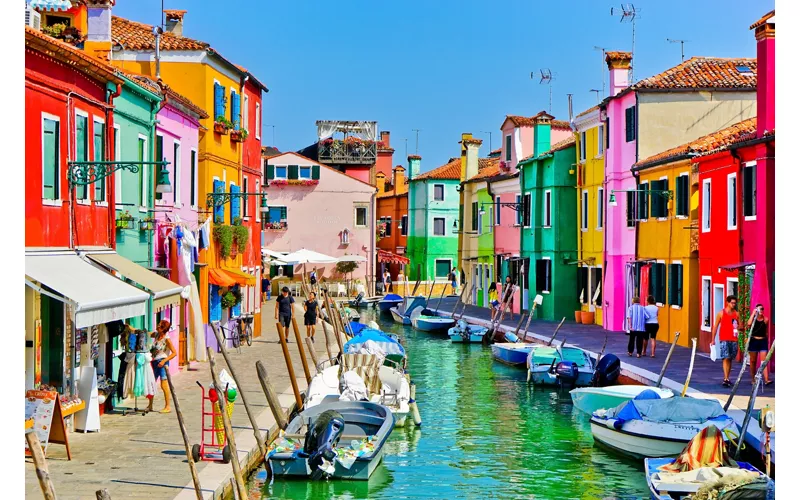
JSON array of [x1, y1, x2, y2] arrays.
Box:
[[25, 301, 333, 500]]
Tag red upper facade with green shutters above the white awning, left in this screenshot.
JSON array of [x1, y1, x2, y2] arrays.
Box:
[[25, 26, 122, 248]]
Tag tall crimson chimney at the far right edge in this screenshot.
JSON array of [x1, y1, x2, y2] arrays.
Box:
[[750, 10, 775, 137]]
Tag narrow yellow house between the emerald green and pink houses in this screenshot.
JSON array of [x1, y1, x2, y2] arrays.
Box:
[[575, 106, 606, 325]]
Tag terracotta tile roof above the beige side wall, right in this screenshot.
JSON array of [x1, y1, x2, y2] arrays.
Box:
[[630, 57, 757, 90]]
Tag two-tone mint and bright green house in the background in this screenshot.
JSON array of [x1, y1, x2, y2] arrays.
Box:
[[408, 156, 461, 280]]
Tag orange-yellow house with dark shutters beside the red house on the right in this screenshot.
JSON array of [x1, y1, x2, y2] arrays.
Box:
[[631, 145, 700, 347]]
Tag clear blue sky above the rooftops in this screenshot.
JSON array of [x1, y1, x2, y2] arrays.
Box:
[[114, 0, 775, 171]]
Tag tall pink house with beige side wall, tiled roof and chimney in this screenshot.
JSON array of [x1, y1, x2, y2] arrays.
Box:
[[600, 52, 756, 330]]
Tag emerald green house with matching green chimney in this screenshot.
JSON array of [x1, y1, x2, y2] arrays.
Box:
[[519, 113, 578, 320]]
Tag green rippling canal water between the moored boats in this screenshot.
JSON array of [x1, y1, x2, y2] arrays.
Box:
[[251, 310, 649, 499]]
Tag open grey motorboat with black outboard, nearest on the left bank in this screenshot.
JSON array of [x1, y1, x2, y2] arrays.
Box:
[[269, 401, 394, 481]]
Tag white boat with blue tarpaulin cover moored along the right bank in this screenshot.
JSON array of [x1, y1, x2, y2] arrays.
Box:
[[590, 391, 738, 460]]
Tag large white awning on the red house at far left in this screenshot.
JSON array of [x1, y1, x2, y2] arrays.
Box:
[[25, 253, 150, 328]]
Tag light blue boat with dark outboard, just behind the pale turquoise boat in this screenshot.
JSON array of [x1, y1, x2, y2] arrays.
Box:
[[526, 345, 596, 388]]
